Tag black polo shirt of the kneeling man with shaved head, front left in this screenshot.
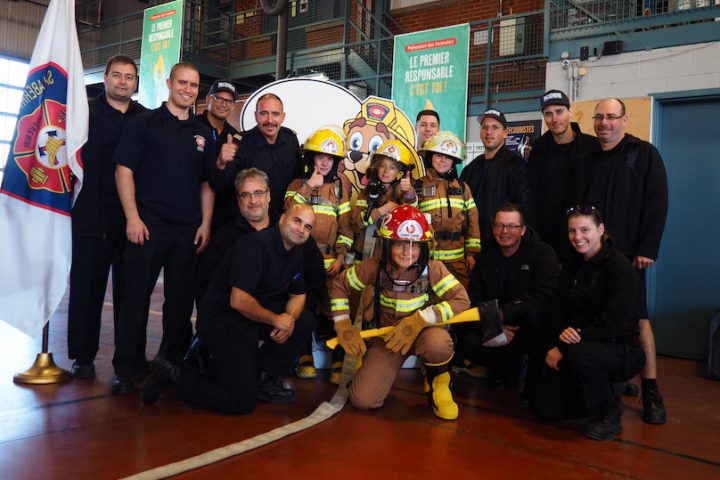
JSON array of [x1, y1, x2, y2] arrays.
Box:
[[197, 225, 305, 332]]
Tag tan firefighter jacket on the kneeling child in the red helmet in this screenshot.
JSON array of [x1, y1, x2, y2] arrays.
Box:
[[330, 258, 470, 326]]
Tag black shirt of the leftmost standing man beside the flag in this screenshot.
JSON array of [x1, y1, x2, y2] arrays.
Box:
[[72, 93, 146, 237]]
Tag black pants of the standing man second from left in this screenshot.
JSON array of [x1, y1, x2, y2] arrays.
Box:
[[113, 224, 197, 375]]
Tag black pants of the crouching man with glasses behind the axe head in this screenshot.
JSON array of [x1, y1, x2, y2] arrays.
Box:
[[455, 308, 552, 394]]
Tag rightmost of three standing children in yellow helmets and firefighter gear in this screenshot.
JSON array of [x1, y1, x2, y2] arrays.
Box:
[[416, 132, 480, 288]]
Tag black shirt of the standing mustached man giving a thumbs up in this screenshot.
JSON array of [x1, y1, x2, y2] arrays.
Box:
[[210, 126, 302, 212]]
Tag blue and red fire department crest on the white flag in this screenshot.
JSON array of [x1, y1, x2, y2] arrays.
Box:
[[2, 63, 72, 212]]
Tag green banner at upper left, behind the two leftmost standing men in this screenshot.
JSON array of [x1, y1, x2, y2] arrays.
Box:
[[139, 0, 184, 108]]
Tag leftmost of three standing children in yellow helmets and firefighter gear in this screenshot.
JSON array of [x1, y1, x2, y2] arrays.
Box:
[[285, 125, 353, 378]]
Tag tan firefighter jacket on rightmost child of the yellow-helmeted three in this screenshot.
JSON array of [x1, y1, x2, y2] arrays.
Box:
[[416, 168, 480, 263]]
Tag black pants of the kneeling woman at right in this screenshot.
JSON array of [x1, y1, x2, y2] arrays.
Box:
[[532, 342, 645, 421]]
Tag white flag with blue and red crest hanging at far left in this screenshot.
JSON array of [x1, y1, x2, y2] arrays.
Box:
[[0, 0, 88, 336]]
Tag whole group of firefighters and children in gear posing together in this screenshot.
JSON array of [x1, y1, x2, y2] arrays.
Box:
[[68, 56, 667, 440]]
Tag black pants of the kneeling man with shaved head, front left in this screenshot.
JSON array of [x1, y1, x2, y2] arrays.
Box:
[[177, 311, 315, 414]]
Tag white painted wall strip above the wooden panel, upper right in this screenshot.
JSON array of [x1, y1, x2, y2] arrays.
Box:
[[545, 42, 720, 100]]
